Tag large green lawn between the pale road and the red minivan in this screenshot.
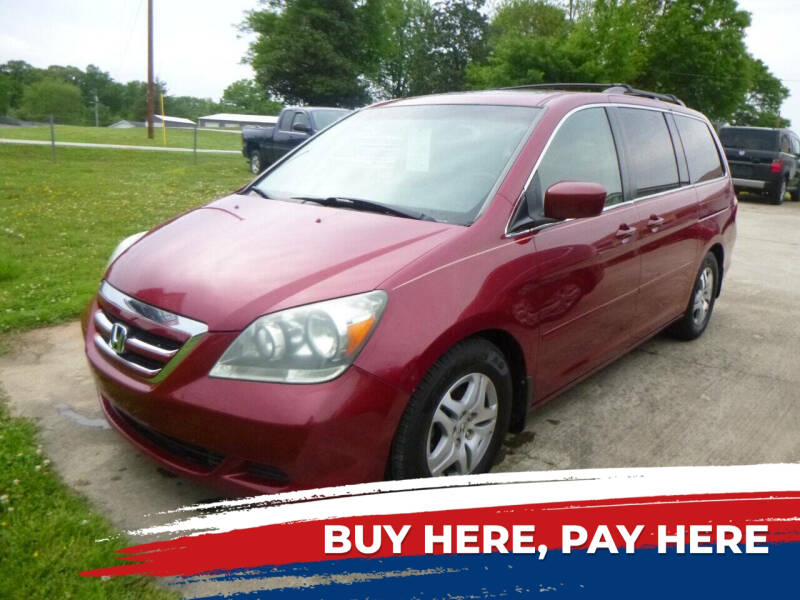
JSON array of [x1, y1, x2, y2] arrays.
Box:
[[0, 145, 251, 332]]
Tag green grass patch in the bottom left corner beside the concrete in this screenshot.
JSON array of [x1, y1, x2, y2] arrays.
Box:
[[0, 397, 178, 600]]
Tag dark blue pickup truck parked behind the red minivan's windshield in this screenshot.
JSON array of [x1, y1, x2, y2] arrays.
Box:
[[242, 106, 350, 175]]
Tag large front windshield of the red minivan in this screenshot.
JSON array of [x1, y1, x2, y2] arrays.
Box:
[[257, 105, 541, 225]]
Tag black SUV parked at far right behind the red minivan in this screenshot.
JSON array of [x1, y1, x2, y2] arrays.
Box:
[[719, 127, 800, 204]]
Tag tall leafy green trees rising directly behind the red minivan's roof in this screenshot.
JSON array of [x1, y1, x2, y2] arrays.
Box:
[[243, 0, 789, 127]]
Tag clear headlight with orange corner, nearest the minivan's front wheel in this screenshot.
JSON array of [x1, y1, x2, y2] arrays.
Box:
[[209, 290, 386, 383]]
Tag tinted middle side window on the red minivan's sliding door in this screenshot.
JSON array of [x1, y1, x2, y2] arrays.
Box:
[[619, 108, 678, 198]]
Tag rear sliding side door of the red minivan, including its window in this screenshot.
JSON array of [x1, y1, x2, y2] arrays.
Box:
[[613, 107, 700, 340]]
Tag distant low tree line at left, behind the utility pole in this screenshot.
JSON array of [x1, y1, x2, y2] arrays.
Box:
[[0, 60, 281, 125]]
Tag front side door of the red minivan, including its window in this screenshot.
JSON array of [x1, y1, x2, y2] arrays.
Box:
[[526, 107, 640, 399]]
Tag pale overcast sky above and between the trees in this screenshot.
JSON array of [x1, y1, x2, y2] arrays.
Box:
[[0, 0, 800, 124]]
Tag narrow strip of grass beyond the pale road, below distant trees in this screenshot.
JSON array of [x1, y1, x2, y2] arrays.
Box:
[[0, 125, 242, 150]]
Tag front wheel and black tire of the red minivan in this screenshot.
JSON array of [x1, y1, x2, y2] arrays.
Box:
[[388, 338, 512, 479]]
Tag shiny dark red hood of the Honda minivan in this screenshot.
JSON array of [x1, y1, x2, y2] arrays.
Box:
[[106, 195, 464, 331]]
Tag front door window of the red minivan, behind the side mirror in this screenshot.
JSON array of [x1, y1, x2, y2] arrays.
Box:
[[527, 108, 622, 217]]
